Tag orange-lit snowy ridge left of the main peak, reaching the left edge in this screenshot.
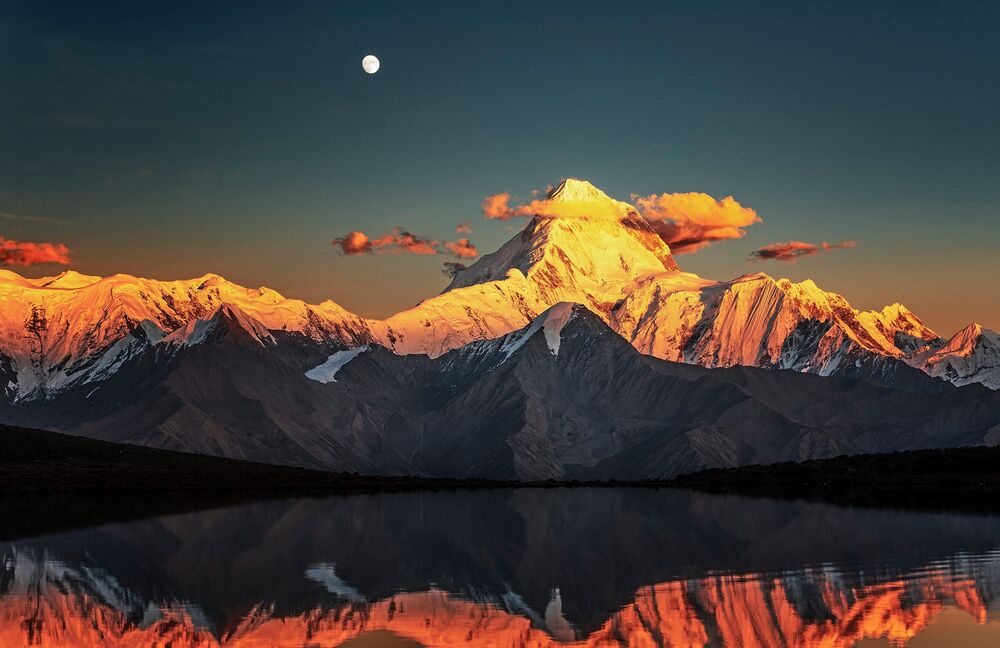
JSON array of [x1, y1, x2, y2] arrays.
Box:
[[0, 271, 371, 399]]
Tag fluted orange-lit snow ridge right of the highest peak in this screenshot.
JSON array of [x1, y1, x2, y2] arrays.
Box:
[[610, 273, 938, 384]]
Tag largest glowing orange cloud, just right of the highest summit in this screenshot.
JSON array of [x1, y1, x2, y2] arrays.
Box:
[[632, 192, 761, 254]]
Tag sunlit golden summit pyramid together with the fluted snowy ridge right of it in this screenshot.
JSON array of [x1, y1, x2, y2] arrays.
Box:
[[376, 180, 968, 389]]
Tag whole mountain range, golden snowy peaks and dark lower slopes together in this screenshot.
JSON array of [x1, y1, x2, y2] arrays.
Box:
[[0, 180, 1000, 479]]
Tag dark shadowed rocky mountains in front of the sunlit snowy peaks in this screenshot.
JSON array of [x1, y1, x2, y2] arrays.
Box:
[[9, 303, 1000, 480]]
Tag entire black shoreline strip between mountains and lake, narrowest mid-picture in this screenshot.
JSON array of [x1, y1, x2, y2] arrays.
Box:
[[0, 426, 1000, 540]]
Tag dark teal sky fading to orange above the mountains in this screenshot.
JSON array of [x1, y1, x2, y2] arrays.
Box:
[[0, 2, 1000, 336]]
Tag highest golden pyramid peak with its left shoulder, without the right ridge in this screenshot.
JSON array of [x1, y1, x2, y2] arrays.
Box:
[[380, 179, 677, 356]]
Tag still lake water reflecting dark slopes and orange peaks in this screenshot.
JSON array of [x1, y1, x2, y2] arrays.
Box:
[[0, 488, 1000, 648]]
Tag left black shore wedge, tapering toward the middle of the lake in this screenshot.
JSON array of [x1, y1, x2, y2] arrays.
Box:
[[0, 425, 508, 540]]
